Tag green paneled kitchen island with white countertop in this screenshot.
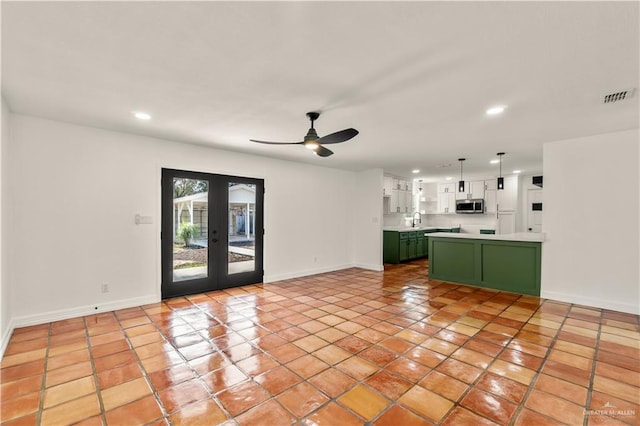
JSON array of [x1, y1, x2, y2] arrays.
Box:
[[429, 232, 544, 296]]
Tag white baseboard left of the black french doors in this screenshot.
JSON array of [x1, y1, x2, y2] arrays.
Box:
[[12, 295, 160, 328]]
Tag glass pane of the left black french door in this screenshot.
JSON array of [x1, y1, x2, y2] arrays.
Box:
[[173, 178, 209, 282]]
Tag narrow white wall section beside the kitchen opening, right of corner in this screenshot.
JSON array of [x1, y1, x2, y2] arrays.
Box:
[[352, 169, 384, 271]]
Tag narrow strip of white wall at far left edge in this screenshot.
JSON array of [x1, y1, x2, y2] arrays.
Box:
[[0, 98, 12, 358]]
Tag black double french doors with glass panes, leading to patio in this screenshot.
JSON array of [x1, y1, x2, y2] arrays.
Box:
[[162, 169, 264, 299]]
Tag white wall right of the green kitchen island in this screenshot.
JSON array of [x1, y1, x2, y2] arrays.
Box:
[[541, 129, 640, 314]]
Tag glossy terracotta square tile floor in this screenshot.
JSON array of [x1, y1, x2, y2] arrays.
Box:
[[0, 261, 640, 426]]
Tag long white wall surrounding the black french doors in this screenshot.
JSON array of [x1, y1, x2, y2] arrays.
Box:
[[3, 114, 370, 325]]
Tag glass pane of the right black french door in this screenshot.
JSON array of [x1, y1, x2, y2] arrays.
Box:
[[227, 182, 256, 274]]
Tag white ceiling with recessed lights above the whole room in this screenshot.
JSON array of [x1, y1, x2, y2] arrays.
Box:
[[2, 1, 640, 179]]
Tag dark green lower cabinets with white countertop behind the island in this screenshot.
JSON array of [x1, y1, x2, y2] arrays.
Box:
[[382, 228, 460, 263]]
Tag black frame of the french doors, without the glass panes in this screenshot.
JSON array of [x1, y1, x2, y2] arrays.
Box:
[[160, 167, 264, 299]]
